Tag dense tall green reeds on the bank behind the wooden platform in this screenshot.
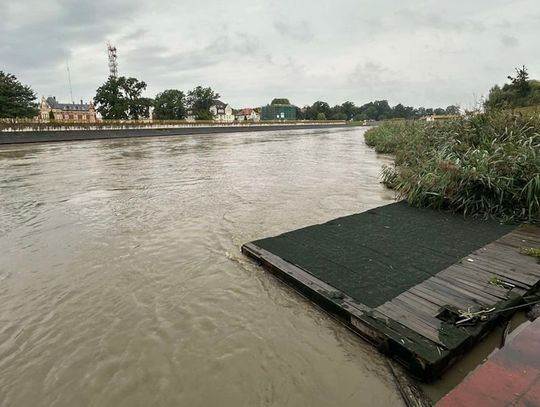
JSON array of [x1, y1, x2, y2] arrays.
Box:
[[365, 113, 540, 223]]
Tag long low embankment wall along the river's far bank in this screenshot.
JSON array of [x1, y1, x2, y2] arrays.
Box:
[[0, 124, 348, 144]]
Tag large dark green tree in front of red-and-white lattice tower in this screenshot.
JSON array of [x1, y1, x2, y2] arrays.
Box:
[[94, 76, 152, 120]]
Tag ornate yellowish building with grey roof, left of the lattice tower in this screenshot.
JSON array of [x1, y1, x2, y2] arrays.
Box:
[[39, 96, 96, 123]]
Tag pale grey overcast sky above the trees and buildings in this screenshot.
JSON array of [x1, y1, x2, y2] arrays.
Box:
[[0, 0, 540, 108]]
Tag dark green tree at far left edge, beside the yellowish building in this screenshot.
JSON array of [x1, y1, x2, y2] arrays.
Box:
[[0, 71, 38, 118]]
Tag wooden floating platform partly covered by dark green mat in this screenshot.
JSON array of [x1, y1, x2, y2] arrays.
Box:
[[242, 203, 540, 381]]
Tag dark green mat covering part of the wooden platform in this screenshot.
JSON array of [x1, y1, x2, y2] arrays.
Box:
[[253, 202, 514, 308]]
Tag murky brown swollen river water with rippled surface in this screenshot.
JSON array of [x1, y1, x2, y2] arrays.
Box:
[[0, 129, 402, 407]]
